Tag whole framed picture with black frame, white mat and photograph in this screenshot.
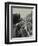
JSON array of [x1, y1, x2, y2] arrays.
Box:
[[5, 3, 37, 43]]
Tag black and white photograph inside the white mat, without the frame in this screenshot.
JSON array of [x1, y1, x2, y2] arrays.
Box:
[[11, 7, 33, 39]]
